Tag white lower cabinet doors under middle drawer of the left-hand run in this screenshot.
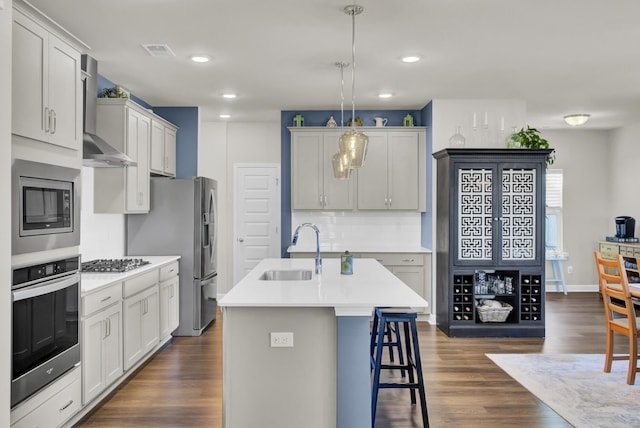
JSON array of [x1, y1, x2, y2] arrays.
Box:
[[124, 283, 160, 371]]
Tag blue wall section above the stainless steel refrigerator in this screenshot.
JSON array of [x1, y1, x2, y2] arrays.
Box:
[[153, 107, 199, 178]]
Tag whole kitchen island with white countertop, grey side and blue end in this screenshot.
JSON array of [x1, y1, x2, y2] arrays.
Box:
[[219, 259, 428, 428]]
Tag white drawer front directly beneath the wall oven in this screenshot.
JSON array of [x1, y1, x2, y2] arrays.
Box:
[[11, 367, 82, 428]]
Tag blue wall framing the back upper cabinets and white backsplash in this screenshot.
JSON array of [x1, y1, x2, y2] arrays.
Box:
[[280, 110, 424, 258]]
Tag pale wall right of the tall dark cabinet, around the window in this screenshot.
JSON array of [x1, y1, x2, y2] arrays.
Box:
[[541, 129, 612, 291]]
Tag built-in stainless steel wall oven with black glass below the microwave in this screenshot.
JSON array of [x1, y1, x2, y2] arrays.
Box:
[[11, 256, 80, 407]]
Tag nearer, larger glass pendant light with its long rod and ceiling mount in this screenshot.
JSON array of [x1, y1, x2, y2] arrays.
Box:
[[340, 5, 369, 169]]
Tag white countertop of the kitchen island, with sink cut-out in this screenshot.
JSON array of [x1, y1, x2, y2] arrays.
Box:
[[218, 259, 429, 316]]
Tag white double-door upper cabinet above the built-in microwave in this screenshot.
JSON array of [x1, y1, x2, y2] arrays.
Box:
[[12, 5, 82, 150]]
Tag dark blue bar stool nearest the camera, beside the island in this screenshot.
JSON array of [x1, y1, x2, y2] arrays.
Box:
[[371, 308, 429, 428]]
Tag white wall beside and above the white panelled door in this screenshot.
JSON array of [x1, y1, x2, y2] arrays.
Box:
[[198, 122, 281, 293]]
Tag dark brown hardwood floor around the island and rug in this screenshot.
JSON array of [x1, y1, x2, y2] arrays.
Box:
[[79, 293, 626, 428]]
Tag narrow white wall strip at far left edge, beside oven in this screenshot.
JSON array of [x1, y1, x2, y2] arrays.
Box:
[[0, 0, 12, 427]]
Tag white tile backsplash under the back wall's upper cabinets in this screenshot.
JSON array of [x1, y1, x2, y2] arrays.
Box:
[[291, 211, 421, 247]]
